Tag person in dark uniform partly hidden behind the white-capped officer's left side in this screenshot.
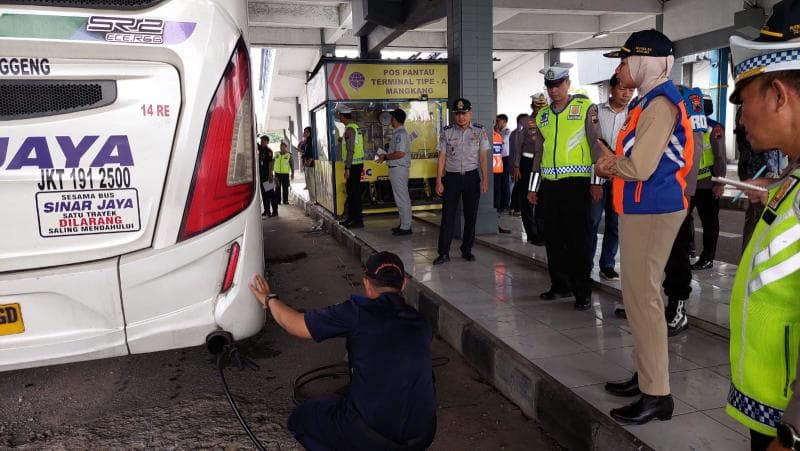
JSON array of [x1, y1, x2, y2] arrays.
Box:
[[511, 92, 547, 246]]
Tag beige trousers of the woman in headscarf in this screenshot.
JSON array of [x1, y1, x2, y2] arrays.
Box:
[[619, 210, 686, 396]]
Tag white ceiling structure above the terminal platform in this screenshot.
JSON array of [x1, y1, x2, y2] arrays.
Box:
[[246, 0, 774, 129]]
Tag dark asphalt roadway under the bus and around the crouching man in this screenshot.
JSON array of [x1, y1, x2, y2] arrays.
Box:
[[0, 206, 559, 451]]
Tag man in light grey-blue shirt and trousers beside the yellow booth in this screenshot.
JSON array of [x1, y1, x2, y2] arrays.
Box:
[[379, 108, 411, 235]]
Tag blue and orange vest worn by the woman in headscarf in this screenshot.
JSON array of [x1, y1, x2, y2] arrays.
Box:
[[612, 81, 694, 214]]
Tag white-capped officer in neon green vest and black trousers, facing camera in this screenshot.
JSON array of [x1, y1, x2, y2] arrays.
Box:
[[528, 64, 604, 310]]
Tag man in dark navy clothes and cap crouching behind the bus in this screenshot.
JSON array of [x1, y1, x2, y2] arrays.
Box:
[[250, 252, 436, 451]]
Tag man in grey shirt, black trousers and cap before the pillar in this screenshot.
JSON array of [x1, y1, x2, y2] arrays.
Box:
[[433, 99, 492, 265]]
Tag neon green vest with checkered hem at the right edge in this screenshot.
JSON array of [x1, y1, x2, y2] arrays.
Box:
[[726, 169, 800, 436]]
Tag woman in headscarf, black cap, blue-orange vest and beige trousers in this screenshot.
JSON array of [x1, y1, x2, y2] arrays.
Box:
[[596, 30, 694, 424]]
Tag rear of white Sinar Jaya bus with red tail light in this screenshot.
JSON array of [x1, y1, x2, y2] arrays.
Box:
[[0, 0, 264, 371]]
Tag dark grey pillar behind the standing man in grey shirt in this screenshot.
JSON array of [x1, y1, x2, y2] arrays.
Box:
[[447, 0, 497, 237]]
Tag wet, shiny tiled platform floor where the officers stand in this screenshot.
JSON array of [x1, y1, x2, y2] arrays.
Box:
[[295, 178, 749, 450]]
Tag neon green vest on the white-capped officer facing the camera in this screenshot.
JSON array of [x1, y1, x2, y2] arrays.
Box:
[[536, 96, 592, 180]]
